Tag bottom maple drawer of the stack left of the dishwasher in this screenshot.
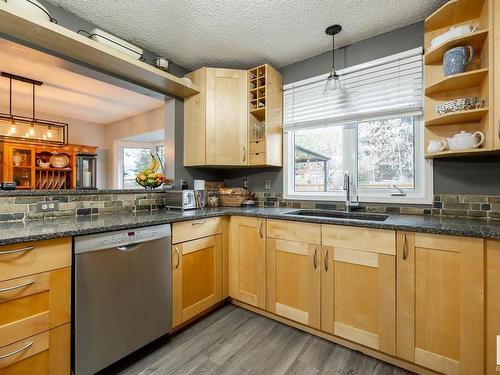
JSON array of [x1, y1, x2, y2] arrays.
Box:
[[0, 324, 70, 375]]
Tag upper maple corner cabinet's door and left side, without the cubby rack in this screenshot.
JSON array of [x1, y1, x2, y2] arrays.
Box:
[[184, 68, 248, 166]]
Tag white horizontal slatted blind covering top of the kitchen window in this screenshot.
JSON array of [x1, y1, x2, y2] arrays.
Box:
[[284, 48, 423, 130]]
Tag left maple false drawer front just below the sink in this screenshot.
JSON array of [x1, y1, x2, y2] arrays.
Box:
[[267, 220, 321, 244]]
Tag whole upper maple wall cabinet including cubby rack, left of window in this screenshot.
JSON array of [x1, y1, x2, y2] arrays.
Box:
[[184, 64, 283, 166]]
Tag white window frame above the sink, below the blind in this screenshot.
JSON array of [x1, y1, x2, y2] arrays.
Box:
[[283, 113, 433, 204]]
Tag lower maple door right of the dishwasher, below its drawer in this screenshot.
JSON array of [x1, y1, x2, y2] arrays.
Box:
[[172, 234, 222, 327]]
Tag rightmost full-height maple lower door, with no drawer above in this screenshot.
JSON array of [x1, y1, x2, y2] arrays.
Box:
[[397, 232, 484, 374]]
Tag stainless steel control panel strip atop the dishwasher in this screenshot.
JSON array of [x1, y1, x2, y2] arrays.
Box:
[[75, 224, 171, 254]]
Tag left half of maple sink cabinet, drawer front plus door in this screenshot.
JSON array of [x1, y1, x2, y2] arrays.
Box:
[[267, 220, 321, 329]]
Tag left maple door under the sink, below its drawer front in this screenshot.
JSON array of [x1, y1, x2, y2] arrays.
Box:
[[267, 238, 320, 329]]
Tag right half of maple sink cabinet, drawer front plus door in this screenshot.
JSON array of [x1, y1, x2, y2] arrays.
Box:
[[321, 225, 396, 354]]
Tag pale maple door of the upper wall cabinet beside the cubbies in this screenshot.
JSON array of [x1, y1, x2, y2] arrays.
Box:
[[205, 68, 248, 165]]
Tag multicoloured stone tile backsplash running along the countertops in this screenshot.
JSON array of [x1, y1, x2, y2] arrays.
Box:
[[0, 188, 500, 221]]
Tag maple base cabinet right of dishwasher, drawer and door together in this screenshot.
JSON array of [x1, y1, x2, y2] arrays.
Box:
[[172, 218, 223, 327]]
